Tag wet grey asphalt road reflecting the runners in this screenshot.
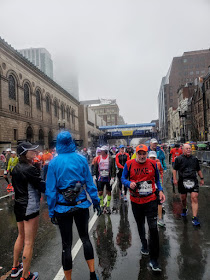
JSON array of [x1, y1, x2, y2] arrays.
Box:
[[0, 167, 210, 280]]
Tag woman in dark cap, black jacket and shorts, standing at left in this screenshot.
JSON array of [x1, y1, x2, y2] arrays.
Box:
[[11, 142, 45, 280]]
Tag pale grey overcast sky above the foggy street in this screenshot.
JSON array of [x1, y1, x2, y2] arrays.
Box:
[[0, 0, 210, 123]]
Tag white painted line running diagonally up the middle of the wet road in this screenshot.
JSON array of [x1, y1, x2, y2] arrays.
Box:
[[53, 180, 117, 280]]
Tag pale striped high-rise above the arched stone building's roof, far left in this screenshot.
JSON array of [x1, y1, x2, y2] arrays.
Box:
[[18, 48, 53, 80]]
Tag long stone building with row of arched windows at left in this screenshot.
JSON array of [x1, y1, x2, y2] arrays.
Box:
[[0, 38, 80, 150]]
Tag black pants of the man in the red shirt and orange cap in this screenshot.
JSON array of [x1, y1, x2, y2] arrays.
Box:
[[131, 200, 159, 260]]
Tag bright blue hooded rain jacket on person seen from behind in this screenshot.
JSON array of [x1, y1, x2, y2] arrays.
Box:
[[45, 131, 100, 218]]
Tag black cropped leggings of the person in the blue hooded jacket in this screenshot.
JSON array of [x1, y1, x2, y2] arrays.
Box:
[[56, 208, 94, 270]]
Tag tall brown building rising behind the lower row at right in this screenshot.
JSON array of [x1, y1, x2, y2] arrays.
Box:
[[158, 49, 210, 141]]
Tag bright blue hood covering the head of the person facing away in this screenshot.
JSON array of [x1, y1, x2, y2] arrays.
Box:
[[56, 131, 76, 154]]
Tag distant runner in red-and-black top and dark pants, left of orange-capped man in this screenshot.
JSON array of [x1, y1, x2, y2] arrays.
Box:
[[115, 145, 130, 201]]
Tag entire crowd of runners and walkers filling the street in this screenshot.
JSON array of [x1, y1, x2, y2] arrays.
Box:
[[4, 134, 204, 280]]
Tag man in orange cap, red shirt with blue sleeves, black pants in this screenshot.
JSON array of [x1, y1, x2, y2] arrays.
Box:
[[122, 144, 165, 271]]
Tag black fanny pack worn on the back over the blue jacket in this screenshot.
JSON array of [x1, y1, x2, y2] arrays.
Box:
[[57, 182, 87, 206]]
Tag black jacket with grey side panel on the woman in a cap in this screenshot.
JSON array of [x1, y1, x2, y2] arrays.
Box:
[[12, 162, 45, 216]]
